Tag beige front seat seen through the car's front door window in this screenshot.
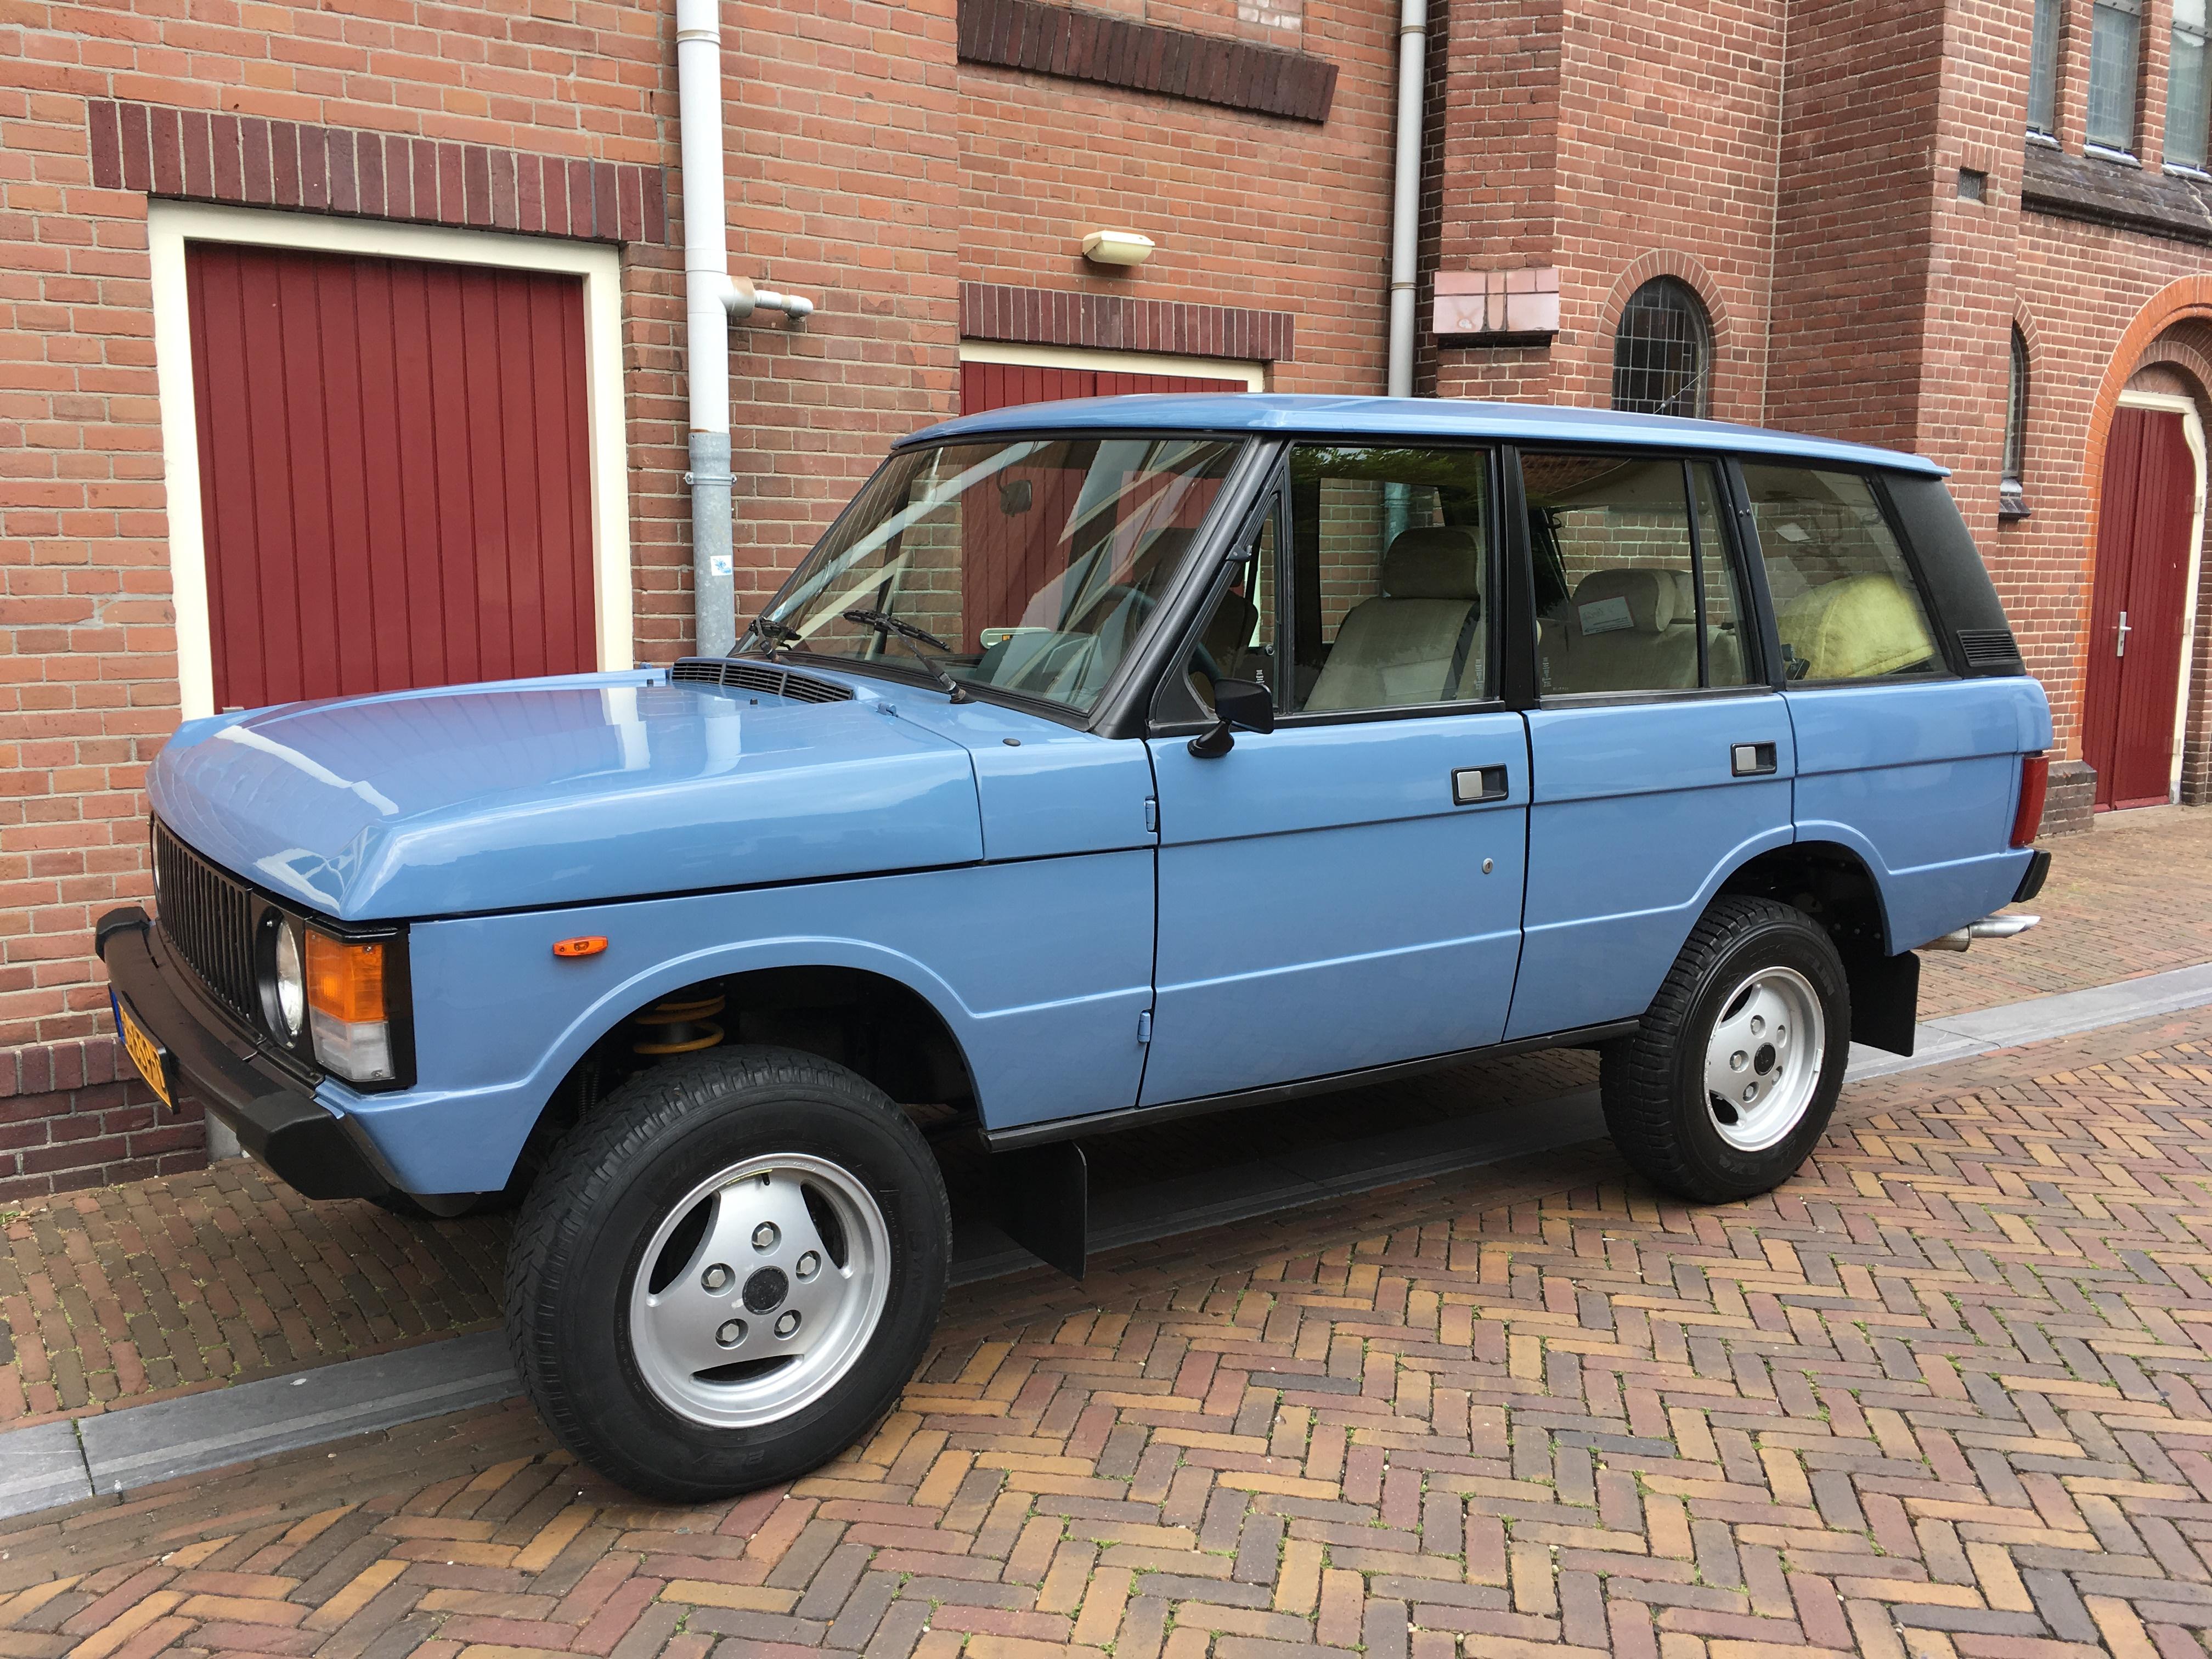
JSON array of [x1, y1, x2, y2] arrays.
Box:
[[1305, 524, 1482, 712]]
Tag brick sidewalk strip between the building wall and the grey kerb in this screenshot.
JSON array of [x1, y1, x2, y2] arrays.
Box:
[[0, 808, 2212, 1425]]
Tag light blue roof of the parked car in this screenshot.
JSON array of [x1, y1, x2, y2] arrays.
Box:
[[900, 392, 1949, 478]]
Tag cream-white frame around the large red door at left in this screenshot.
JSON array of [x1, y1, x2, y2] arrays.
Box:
[[146, 201, 630, 719]]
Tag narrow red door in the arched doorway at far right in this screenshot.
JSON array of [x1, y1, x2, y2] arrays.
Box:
[[2081, 409, 2197, 808]]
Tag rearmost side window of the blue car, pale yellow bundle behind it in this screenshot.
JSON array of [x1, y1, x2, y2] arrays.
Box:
[[1743, 462, 1942, 679]]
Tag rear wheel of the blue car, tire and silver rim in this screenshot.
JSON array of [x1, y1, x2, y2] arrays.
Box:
[[1599, 896, 1852, 1203]]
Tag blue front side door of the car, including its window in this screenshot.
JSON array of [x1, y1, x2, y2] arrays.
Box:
[[1144, 444, 1528, 1104]]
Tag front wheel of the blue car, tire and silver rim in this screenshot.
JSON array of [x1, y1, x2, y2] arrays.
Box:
[[506, 1046, 951, 1502]]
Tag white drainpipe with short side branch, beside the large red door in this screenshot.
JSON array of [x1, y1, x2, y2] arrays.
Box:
[[677, 0, 814, 657]]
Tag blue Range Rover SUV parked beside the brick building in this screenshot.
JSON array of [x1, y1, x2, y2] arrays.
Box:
[[99, 396, 2051, 1500]]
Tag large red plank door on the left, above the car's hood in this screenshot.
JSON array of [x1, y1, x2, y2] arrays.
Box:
[[186, 244, 597, 708]]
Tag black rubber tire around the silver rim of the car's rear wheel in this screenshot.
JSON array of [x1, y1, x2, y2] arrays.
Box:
[[1599, 896, 1852, 1203]]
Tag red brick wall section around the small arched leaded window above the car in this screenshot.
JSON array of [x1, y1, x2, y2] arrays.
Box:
[[1425, 0, 1781, 420]]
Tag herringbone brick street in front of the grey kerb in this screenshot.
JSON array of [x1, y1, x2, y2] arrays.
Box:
[[0, 1013, 2212, 1659]]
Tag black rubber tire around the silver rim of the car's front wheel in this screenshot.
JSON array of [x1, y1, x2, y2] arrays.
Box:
[[506, 1046, 951, 1504]]
